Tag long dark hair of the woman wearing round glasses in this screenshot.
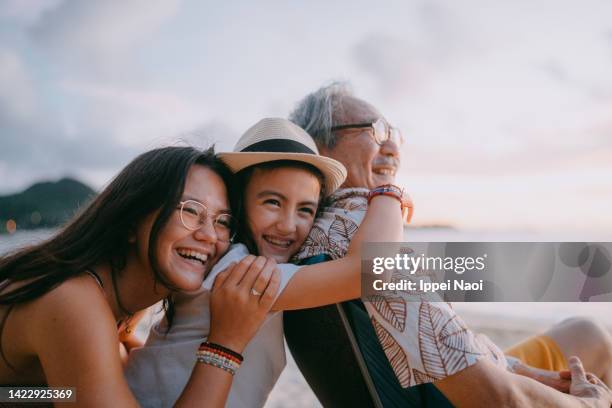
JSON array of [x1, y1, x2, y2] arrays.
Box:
[[0, 146, 231, 314]]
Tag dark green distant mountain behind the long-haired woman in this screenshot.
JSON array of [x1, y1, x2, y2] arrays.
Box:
[[0, 178, 96, 233]]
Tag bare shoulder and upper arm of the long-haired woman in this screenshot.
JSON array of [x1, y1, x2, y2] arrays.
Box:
[[10, 276, 138, 406]]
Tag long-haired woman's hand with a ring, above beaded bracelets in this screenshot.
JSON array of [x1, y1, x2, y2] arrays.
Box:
[[208, 255, 280, 353]]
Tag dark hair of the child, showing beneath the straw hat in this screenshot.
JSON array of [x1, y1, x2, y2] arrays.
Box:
[[231, 160, 325, 255]]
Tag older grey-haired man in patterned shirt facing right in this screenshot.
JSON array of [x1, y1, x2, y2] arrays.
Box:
[[285, 83, 612, 407]]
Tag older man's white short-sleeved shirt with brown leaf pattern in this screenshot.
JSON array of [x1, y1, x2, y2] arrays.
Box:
[[292, 188, 508, 387]]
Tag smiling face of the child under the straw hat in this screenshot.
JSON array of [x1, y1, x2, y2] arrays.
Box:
[[244, 167, 321, 263]]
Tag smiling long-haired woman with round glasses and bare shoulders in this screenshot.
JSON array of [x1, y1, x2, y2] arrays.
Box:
[[0, 147, 279, 407]]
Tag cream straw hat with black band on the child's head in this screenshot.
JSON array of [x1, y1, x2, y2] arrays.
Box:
[[219, 118, 346, 195]]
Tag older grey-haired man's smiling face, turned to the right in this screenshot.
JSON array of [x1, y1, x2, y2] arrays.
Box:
[[320, 98, 400, 189]]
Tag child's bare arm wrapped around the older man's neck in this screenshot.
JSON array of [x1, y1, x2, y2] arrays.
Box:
[[272, 196, 403, 310]]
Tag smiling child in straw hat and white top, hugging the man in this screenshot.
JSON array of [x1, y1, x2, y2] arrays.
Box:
[[126, 119, 403, 407]]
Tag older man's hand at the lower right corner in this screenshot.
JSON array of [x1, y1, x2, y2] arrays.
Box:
[[561, 357, 612, 408]]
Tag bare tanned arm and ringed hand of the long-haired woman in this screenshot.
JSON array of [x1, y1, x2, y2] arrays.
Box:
[[25, 259, 278, 407]]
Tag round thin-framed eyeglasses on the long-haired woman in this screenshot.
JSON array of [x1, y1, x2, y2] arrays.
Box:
[[177, 200, 236, 242]]
